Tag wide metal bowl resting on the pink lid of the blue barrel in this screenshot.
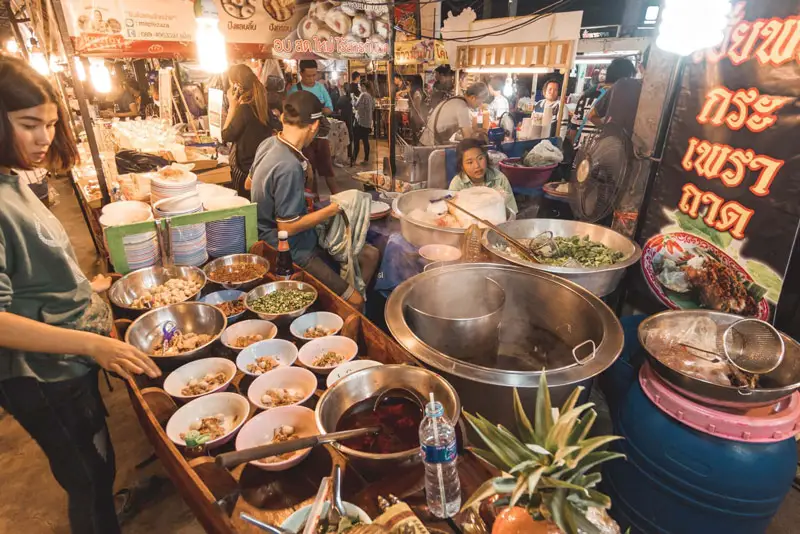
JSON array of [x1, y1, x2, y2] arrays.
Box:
[[639, 310, 800, 409]]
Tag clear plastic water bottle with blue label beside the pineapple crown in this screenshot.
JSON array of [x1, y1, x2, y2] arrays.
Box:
[[419, 393, 461, 518]]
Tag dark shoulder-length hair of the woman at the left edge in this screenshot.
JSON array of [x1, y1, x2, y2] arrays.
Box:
[[0, 56, 79, 171]]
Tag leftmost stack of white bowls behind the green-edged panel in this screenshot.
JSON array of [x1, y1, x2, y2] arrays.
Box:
[[100, 200, 161, 270]]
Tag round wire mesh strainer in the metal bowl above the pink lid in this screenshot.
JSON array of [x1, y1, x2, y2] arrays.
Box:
[[722, 319, 786, 375]]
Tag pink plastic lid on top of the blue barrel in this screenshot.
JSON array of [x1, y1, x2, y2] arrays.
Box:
[[639, 364, 800, 443]]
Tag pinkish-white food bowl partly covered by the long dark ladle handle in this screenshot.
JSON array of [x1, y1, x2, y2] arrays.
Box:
[[236, 406, 319, 471]]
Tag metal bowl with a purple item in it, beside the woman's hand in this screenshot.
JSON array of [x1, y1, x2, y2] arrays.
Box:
[[125, 302, 228, 361]]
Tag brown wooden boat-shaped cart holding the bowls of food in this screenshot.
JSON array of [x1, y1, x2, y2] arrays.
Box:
[[118, 245, 492, 534]]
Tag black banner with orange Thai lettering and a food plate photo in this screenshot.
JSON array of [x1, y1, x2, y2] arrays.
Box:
[[639, 0, 800, 320]]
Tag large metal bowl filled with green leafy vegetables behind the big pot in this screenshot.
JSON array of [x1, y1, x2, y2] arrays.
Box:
[[481, 219, 642, 297]]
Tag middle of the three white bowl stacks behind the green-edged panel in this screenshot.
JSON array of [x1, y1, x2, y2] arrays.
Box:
[[153, 193, 208, 267]]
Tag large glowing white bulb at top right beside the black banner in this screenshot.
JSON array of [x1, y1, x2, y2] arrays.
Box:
[[656, 0, 731, 56]]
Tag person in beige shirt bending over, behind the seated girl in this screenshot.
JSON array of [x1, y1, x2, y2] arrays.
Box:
[[420, 83, 489, 146]]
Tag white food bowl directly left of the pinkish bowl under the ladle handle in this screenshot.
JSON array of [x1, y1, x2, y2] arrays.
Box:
[[166, 392, 253, 449]]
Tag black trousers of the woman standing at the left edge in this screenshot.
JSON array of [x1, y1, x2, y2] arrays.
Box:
[[0, 371, 120, 534]]
